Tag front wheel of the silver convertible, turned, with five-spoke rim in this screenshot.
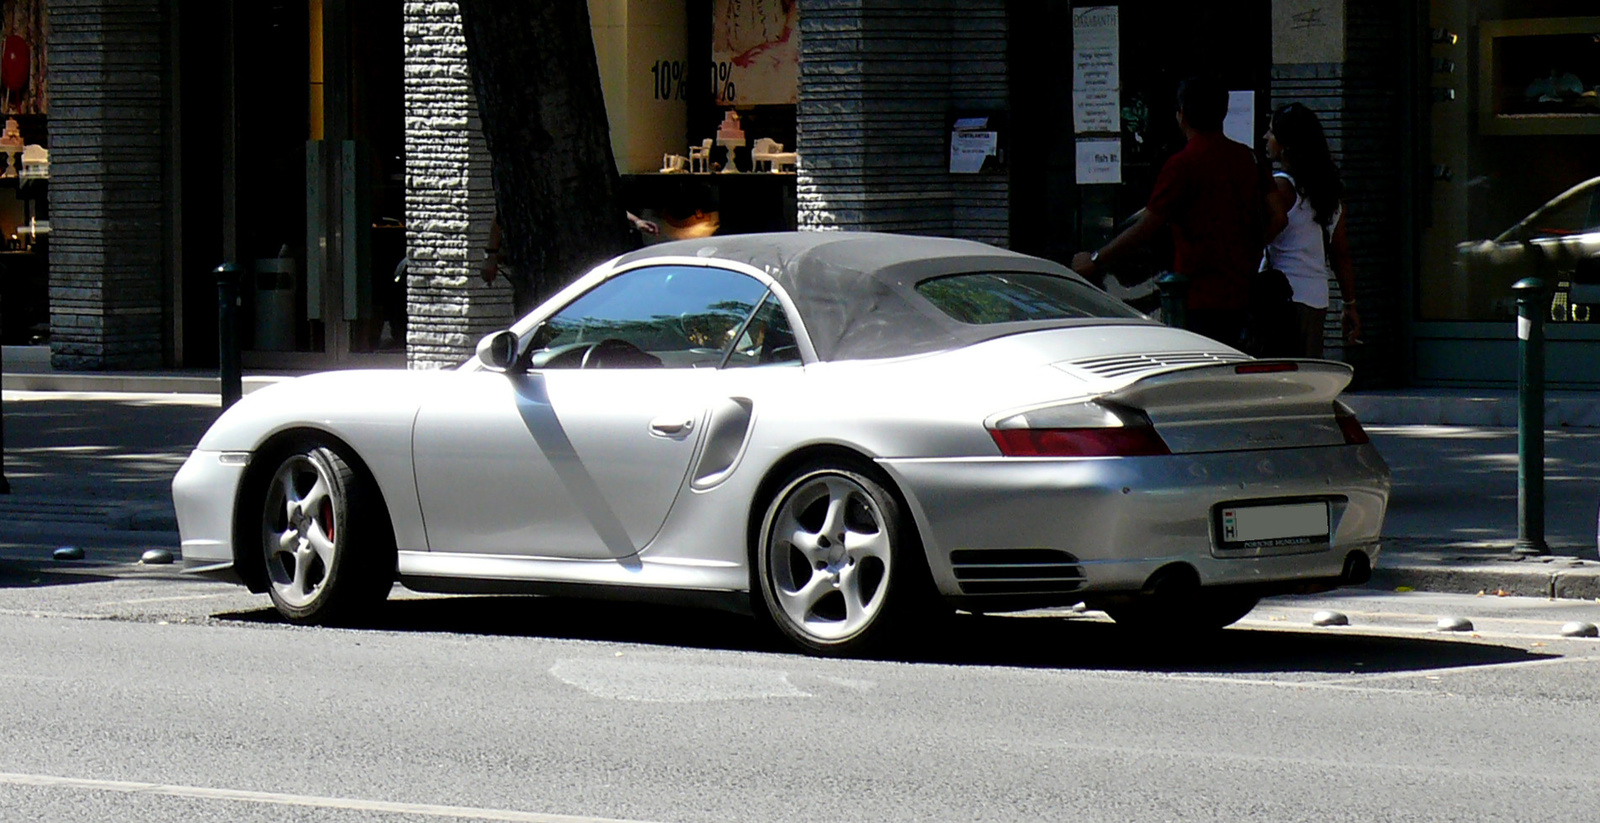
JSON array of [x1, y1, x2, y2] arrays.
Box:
[[261, 444, 394, 623]]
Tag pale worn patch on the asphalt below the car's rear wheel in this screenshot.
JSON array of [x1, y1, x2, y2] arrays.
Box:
[[550, 658, 811, 703]]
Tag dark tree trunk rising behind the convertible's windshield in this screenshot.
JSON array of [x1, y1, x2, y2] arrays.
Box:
[[459, 0, 630, 314]]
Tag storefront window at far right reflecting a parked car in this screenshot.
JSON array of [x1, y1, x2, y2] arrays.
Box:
[[1418, 8, 1600, 323]]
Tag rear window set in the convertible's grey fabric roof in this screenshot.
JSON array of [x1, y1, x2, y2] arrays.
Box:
[[917, 272, 1142, 325]]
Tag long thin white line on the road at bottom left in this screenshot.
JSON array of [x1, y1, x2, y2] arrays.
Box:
[[0, 772, 665, 823]]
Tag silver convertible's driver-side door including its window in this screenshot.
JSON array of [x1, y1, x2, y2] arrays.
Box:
[[413, 266, 766, 559]]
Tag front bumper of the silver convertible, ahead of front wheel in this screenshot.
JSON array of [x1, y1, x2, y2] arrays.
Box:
[[173, 448, 248, 581]]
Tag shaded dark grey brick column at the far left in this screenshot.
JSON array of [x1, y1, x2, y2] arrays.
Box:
[[50, 0, 166, 370]]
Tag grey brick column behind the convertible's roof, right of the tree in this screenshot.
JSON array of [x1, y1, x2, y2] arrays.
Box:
[[797, 0, 1011, 245]]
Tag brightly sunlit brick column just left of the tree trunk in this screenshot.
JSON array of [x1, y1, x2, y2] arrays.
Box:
[[405, 0, 512, 368]]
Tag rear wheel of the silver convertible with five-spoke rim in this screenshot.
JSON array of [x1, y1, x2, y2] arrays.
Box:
[[757, 461, 934, 655]]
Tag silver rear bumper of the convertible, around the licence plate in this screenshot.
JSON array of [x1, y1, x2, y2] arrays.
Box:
[[880, 445, 1389, 605]]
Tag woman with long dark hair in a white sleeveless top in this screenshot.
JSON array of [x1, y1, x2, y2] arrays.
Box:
[[1266, 102, 1362, 357]]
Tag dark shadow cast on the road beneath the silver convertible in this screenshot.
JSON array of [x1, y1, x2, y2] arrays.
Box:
[[216, 596, 1555, 674]]
